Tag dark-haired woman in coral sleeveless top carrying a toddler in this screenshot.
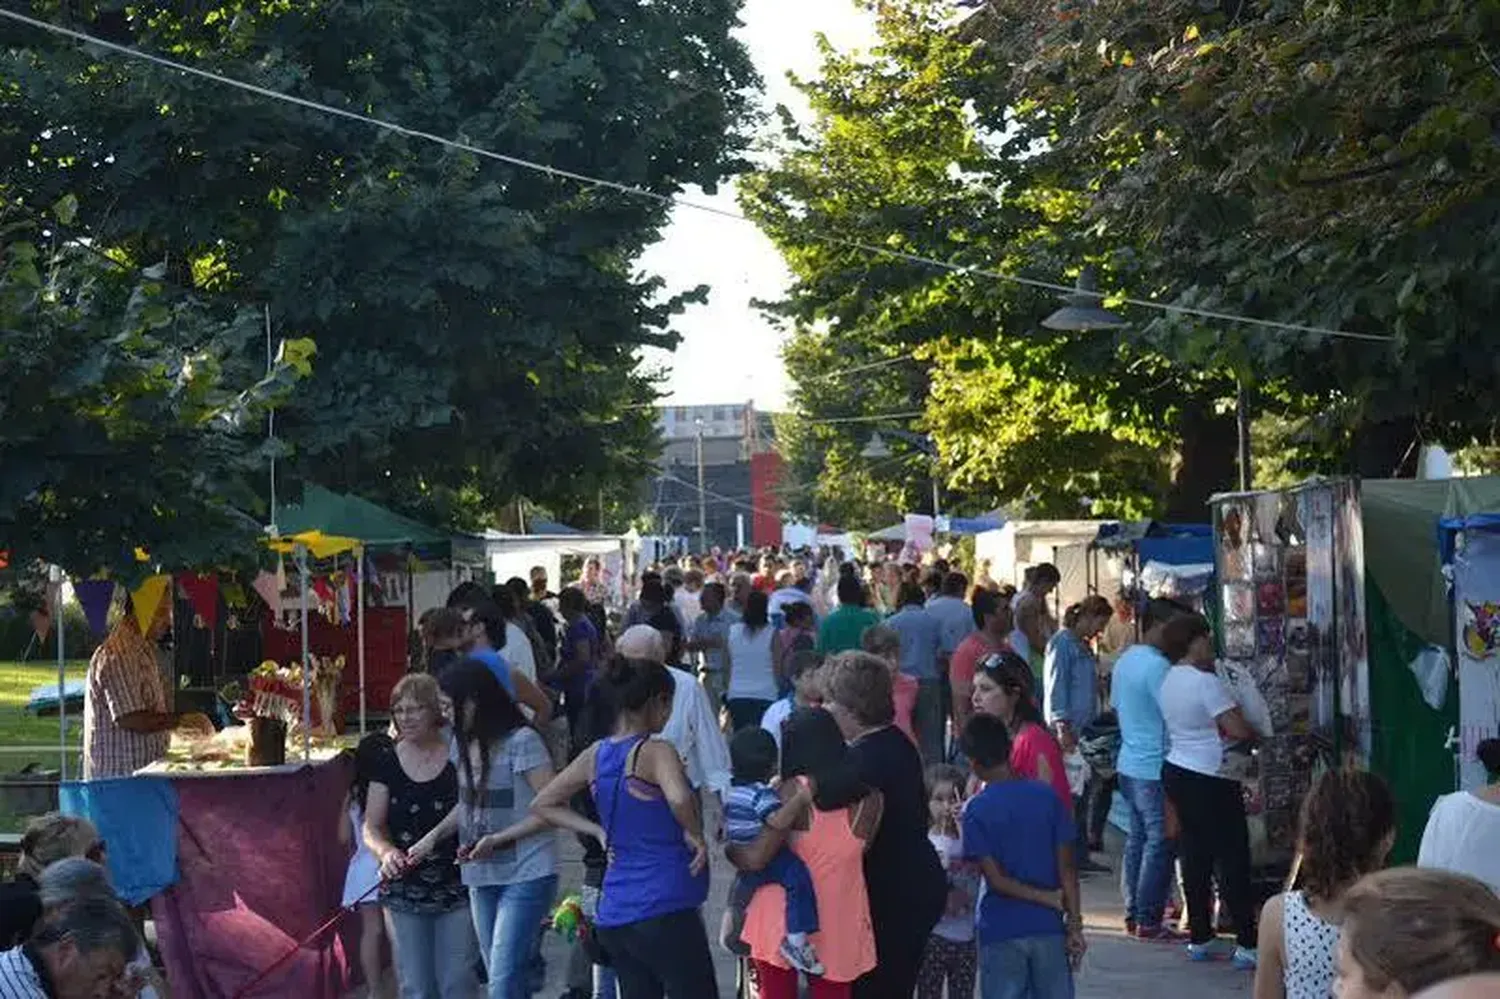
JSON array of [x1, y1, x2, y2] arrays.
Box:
[[729, 708, 884, 999]]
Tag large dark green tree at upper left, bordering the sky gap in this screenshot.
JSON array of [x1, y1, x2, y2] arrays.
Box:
[[0, 0, 756, 527]]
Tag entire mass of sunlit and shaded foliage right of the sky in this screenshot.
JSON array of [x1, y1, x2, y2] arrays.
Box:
[[746, 0, 1500, 519]]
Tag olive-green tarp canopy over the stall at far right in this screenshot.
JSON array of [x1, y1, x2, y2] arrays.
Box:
[[1359, 476, 1500, 645]]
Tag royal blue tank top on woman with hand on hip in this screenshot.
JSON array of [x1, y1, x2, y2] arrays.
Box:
[[593, 735, 708, 929]]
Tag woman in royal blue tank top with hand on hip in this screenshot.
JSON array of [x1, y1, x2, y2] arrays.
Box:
[[531, 659, 719, 999]]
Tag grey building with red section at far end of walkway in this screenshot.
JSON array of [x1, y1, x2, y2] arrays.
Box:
[[645, 402, 783, 549]]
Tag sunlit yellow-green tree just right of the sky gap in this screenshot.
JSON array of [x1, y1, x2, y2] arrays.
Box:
[[744, 3, 1233, 519]]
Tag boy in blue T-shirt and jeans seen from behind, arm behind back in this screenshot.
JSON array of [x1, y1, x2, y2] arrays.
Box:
[[960, 714, 1085, 999]]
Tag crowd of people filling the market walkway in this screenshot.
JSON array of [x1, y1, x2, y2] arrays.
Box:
[[20, 557, 1500, 999]]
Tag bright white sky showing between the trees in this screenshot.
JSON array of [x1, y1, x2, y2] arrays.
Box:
[[641, 0, 875, 411]]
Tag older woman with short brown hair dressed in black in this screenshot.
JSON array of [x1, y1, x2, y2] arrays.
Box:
[[822, 653, 948, 999]]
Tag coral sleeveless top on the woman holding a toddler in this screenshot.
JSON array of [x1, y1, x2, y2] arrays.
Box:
[[741, 779, 875, 983]]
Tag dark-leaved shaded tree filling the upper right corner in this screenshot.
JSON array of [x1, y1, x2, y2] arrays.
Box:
[[969, 0, 1500, 476]]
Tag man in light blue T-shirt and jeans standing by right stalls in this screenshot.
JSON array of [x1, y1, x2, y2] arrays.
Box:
[[1110, 600, 1187, 941]]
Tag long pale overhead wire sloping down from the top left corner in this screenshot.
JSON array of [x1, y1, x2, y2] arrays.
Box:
[[0, 8, 1397, 342]]
